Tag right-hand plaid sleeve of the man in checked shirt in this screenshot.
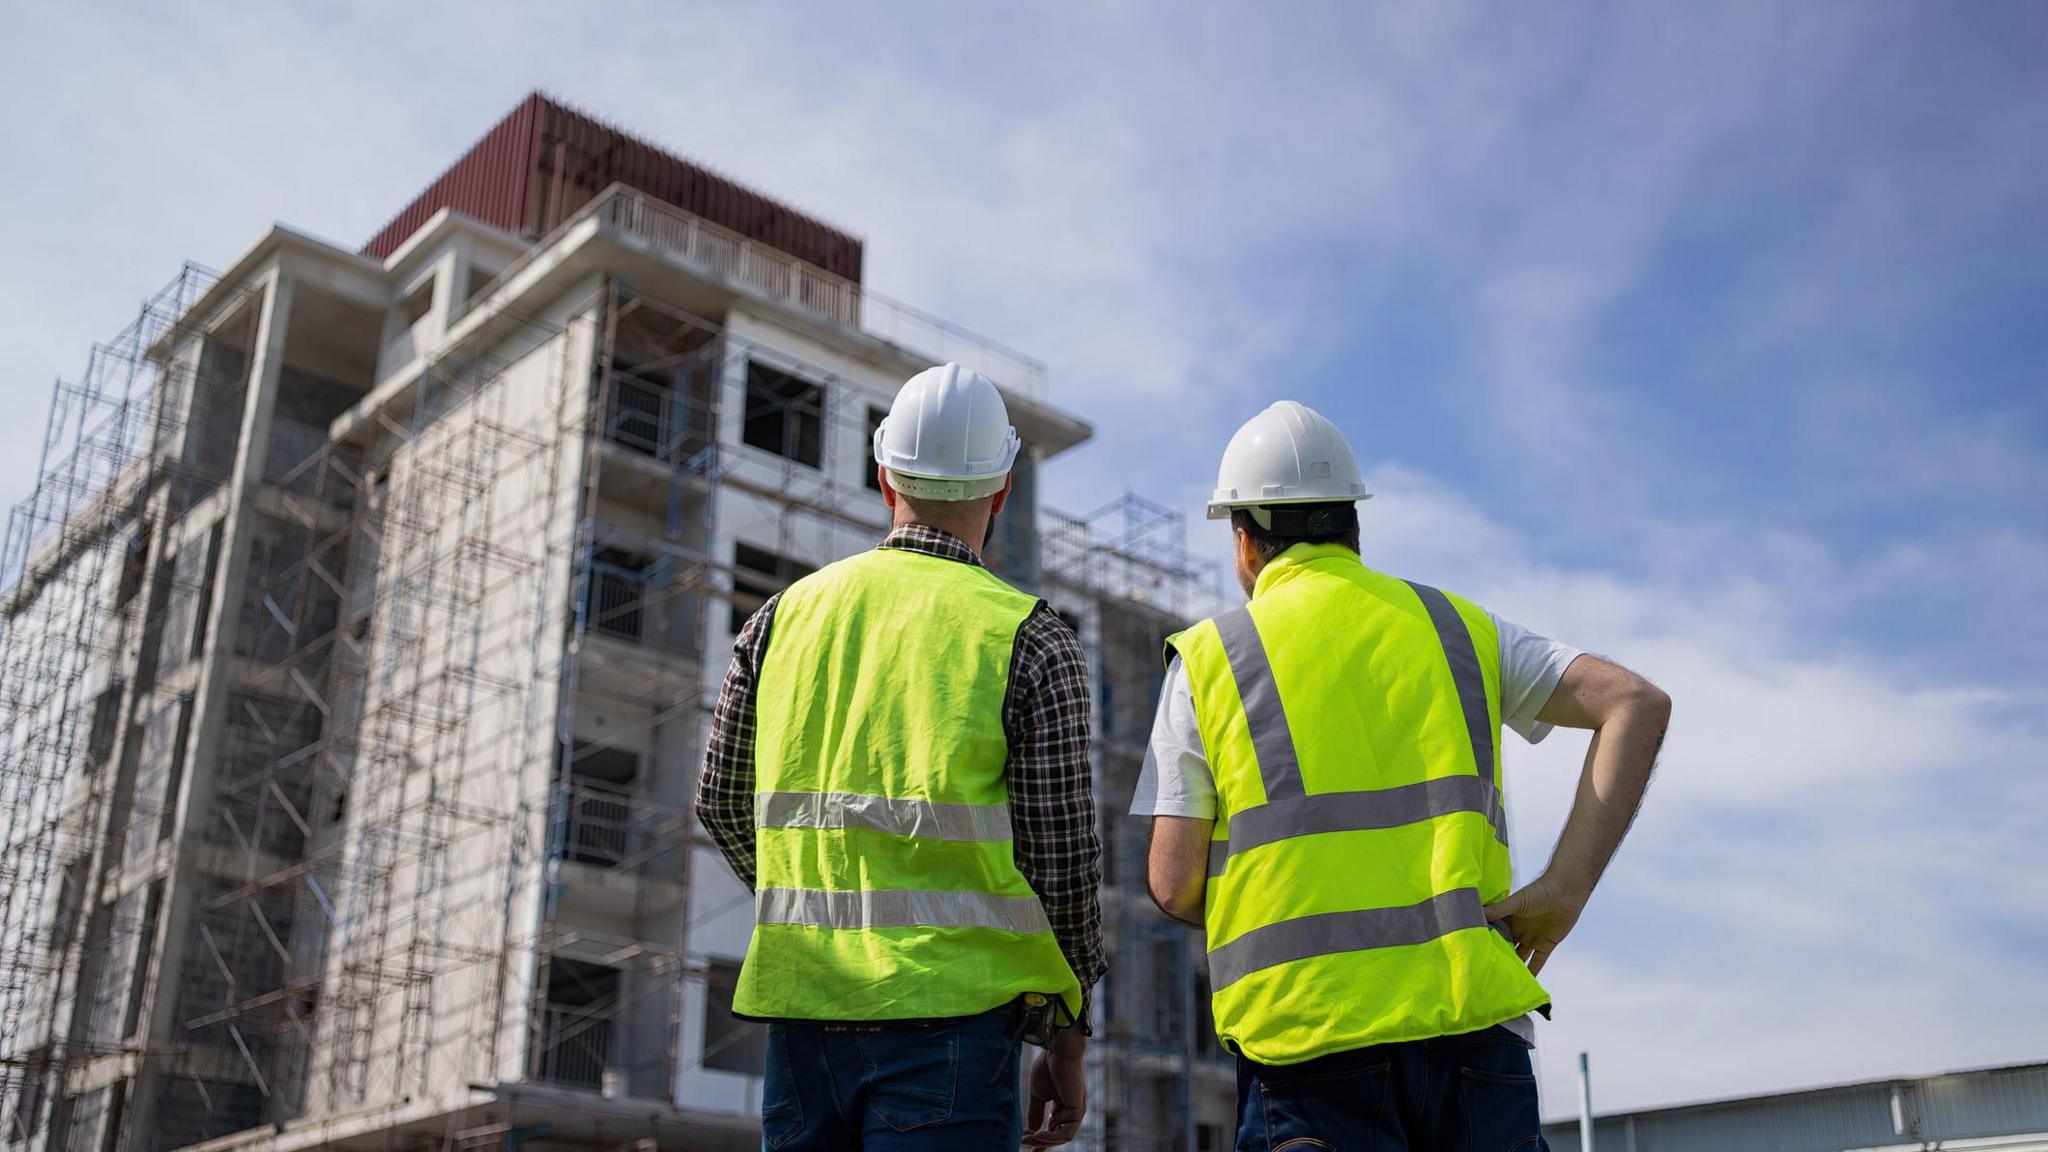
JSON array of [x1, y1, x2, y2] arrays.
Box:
[[1004, 605, 1110, 1031]]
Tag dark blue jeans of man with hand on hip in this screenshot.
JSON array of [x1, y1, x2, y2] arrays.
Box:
[[1237, 1027, 1548, 1152]]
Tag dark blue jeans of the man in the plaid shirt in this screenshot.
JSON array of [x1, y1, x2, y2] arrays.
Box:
[[762, 1004, 1024, 1152]]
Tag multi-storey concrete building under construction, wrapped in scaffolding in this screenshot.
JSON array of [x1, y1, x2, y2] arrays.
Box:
[[0, 96, 1233, 1152]]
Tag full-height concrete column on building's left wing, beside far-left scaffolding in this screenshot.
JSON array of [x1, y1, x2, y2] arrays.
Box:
[[123, 269, 293, 1152]]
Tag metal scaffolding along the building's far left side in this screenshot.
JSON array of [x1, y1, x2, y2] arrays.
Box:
[[0, 264, 264, 1140]]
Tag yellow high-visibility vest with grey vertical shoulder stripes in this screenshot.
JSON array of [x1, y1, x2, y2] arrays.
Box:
[[1167, 545, 1550, 1064]]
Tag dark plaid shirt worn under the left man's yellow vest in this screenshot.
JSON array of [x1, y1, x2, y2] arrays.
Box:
[[696, 525, 1108, 1029]]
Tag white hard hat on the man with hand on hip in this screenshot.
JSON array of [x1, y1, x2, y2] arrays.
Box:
[[1208, 400, 1372, 521]]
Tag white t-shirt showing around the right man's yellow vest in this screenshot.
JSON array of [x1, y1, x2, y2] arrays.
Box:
[[1130, 613, 1581, 1041]]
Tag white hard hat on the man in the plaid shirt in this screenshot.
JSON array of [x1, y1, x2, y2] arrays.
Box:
[[874, 365, 1020, 500]]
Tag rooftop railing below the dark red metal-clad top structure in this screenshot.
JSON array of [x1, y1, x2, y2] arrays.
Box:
[[577, 184, 1047, 400]]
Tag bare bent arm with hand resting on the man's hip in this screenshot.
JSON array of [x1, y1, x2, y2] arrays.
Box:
[[1487, 656, 1671, 972]]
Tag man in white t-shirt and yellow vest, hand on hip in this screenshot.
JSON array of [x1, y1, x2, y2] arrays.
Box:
[[1133, 400, 1671, 1152]]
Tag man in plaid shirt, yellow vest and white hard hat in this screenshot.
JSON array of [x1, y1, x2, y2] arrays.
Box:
[[696, 365, 1106, 1150]]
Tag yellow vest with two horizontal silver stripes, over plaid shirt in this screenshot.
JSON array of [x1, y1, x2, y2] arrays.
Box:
[[733, 547, 1081, 1021]]
